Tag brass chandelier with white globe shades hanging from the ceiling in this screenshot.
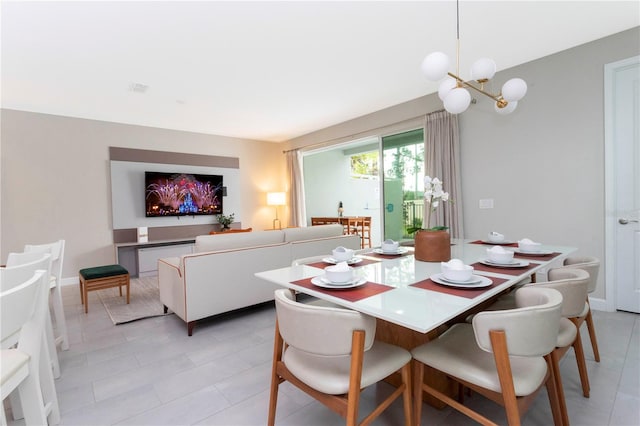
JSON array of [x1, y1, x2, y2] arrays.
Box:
[[422, 0, 527, 114]]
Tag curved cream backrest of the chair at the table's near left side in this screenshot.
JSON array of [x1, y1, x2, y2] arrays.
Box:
[[275, 289, 376, 356]]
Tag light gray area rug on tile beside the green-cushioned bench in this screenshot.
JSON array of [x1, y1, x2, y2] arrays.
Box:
[[97, 277, 172, 325]]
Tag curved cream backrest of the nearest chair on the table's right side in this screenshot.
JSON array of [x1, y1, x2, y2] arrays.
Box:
[[473, 286, 562, 356]]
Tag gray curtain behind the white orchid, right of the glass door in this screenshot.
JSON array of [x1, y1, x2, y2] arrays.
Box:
[[424, 111, 464, 238]]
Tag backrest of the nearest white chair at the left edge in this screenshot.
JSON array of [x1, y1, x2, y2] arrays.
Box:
[[0, 270, 49, 355]]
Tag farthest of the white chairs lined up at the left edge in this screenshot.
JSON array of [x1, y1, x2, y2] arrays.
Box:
[[24, 240, 69, 351]]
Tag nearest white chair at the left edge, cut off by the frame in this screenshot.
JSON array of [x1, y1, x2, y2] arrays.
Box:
[[0, 269, 60, 426]]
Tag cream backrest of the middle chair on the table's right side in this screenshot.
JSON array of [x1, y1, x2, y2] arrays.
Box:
[[528, 268, 591, 318]]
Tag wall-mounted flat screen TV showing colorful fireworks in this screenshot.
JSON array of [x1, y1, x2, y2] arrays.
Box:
[[144, 172, 223, 217]]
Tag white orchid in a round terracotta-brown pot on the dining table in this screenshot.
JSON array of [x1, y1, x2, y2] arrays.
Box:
[[412, 176, 451, 262]]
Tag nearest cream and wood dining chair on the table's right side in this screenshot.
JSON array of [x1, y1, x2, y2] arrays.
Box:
[[411, 287, 562, 425]]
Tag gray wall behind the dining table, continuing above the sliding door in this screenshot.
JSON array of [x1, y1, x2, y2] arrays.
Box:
[[287, 27, 640, 299]]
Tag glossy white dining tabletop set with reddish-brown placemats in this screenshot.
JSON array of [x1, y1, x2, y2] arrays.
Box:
[[255, 240, 576, 333]]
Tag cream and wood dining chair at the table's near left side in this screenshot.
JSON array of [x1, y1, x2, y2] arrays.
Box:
[[267, 289, 412, 426]]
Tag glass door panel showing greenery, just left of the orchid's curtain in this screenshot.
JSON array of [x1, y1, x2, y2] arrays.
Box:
[[382, 129, 424, 241]]
